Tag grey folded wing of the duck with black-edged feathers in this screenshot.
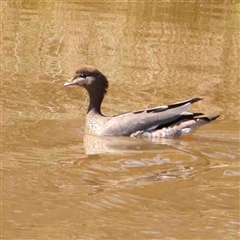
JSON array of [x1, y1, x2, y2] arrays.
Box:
[[100, 98, 201, 136]]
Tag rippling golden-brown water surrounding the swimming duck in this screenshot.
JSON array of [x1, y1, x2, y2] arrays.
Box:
[[1, 1, 240, 240]]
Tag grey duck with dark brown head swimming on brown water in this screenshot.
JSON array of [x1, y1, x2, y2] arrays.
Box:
[[64, 65, 220, 138]]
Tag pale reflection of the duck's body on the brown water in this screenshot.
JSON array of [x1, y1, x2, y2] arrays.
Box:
[[83, 133, 178, 155]]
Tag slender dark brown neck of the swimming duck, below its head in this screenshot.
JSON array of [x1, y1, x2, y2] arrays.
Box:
[[87, 90, 104, 115]]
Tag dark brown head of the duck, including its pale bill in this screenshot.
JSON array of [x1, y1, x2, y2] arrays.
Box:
[[64, 66, 108, 94]]
